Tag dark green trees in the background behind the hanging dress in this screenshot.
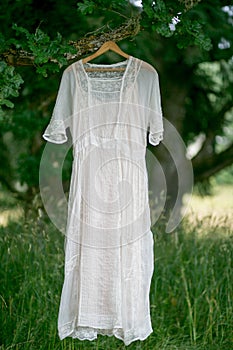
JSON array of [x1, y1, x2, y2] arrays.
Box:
[[0, 0, 233, 216]]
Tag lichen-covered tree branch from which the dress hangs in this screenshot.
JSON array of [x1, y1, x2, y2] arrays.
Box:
[[0, 16, 140, 66]]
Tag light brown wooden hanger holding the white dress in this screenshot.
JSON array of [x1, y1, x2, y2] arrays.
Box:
[[82, 41, 129, 71]]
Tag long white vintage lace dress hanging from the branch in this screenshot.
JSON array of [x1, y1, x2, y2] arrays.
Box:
[[43, 56, 163, 345]]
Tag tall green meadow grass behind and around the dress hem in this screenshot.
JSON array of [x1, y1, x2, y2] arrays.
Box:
[[0, 186, 233, 350]]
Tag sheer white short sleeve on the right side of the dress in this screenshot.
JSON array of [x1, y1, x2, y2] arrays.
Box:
[[148, 70, 164, 146]]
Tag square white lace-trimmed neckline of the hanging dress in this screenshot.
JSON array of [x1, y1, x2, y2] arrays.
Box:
[[79, 56, 133, 82]]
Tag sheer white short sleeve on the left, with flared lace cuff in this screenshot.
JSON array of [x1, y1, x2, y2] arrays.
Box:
[[43, 67, 74, 143]]
